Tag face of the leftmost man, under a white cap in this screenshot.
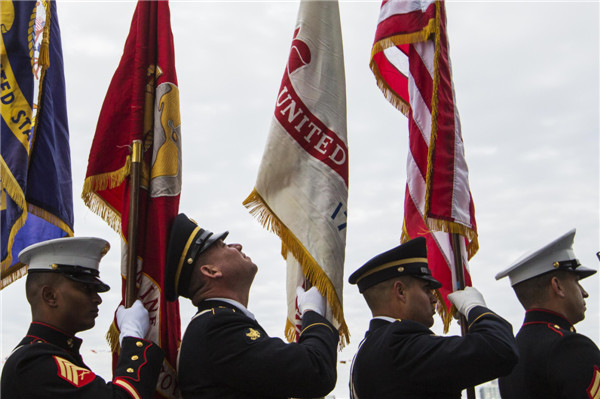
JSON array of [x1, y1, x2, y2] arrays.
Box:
[[57, 277, 102, 335]]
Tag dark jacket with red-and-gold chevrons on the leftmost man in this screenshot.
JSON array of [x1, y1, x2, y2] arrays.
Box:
[[0, 322, 164, 399]]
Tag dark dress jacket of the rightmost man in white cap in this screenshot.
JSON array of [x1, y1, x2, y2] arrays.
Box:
[[498, 309, 600, 399]]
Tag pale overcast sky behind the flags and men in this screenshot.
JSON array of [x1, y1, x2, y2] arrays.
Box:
[[1, 1, 600, 398]]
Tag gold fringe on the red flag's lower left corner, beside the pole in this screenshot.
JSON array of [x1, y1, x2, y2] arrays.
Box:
[[81, 155, 131, 234]]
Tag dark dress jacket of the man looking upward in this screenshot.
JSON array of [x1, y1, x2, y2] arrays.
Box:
[[178, 300, 339, 399]]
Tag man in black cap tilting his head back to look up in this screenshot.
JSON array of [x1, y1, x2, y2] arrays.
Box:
[[165, 214, 339, 399]]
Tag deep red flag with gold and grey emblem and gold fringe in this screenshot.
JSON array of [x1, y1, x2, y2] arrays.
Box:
[[82, 1, 181, 398]]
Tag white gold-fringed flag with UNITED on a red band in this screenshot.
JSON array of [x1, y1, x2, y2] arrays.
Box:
[[244, 1, 348, 342]]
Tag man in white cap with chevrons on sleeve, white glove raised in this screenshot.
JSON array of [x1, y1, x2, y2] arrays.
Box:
[[0, 237, 164, 399]]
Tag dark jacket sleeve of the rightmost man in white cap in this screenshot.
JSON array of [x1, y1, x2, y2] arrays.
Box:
[[545, 334, 600, 399]]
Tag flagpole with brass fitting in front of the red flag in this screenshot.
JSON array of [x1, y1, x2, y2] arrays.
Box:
[[125, 140, 142, 308]]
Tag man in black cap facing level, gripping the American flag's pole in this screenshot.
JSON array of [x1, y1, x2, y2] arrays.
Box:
[[349, 237, 518, 399]]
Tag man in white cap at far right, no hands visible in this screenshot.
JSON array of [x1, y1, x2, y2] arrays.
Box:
[[496, 229, 600, 399]]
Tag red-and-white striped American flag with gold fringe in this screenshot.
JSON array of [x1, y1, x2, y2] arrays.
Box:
[[370, 0, 478, 330]]
